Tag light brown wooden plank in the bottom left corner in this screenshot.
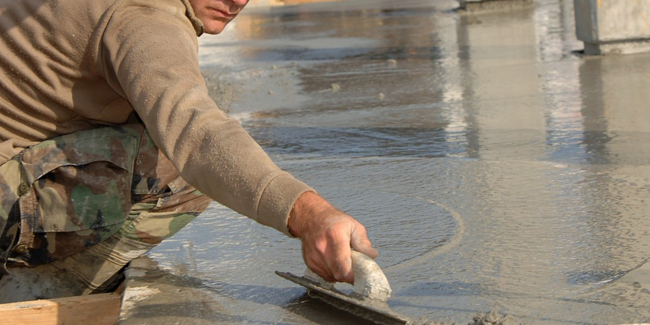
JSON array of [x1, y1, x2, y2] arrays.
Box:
[[0, 293, 122, 325]]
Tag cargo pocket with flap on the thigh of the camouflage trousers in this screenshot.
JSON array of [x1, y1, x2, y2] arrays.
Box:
[[14, 125, 143, 265]]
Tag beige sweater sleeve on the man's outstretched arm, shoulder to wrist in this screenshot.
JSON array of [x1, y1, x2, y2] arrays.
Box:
[[102, 3, 313, 235]]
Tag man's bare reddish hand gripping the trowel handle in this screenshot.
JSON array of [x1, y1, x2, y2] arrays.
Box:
[[288, 192, 378, 283]]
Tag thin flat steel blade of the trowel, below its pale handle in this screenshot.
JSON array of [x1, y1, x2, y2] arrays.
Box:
[[275, 271, 410, 325]]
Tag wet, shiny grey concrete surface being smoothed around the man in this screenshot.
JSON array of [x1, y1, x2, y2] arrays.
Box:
[[120, 0, 650, 324]]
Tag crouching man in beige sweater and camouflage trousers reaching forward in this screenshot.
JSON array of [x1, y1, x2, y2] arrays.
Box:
[[0, 0, 377, 296]]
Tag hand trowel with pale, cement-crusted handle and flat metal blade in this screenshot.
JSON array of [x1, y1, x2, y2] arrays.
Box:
[[275, 251, 411, 325]]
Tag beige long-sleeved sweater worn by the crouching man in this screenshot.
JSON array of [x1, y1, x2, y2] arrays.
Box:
[[0, 0, 311, 234]]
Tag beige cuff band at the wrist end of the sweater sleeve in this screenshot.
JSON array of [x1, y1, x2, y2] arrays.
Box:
[[257, 173, 316, 237]]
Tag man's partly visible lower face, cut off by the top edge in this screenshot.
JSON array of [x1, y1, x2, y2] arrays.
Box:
[[189, 0, 248, 34]]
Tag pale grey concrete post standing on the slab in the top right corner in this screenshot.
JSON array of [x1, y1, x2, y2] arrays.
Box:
[[574, 0, 650, 55]]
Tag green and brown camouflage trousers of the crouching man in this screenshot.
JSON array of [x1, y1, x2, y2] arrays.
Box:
[[0, 124, 211, 293]]
